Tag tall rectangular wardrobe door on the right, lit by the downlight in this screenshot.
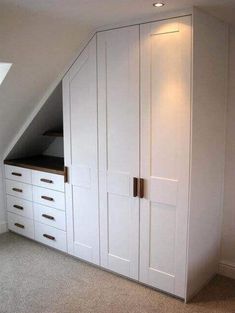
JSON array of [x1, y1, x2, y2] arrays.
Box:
[[140, 17, 191, 298]]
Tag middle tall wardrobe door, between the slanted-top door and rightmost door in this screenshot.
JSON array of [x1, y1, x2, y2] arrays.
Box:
[[98, 26, 139, 279]]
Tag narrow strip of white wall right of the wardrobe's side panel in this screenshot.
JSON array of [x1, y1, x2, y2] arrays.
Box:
[[220, 28, 235, 278]]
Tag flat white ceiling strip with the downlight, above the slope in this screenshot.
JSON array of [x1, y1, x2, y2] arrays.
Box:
[[0, 0, 235, 27]]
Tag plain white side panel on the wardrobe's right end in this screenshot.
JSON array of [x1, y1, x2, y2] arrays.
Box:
[[187, 10, 227, 298]]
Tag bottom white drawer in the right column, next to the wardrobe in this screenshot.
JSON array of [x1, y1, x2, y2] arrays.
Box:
[[35, 222, 67, 252]]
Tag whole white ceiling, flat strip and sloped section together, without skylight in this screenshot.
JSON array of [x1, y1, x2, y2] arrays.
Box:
[[0, 0, 235, 157]]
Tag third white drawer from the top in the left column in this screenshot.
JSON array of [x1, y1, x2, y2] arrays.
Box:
[[7, 195, 33, 219]]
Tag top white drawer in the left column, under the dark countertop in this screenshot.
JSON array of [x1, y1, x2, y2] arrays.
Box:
[[5, 165, 32, 184]]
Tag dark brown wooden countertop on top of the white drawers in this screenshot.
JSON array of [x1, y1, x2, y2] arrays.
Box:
[[4, 155, 65, 176]]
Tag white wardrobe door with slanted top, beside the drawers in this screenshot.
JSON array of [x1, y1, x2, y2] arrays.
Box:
[[63, 36, 99, 264]]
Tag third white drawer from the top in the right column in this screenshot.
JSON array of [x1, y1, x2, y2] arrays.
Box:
[[33, 203, 65, 230]]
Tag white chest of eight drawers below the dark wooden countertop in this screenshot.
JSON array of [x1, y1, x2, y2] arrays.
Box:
[[5, 165, 67, 252]]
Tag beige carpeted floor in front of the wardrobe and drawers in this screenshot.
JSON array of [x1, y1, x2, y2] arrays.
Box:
[[0, 233, 235, 313]]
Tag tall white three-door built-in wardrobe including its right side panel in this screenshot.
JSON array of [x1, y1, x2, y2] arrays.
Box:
[[63, 10, 227, 299]]
